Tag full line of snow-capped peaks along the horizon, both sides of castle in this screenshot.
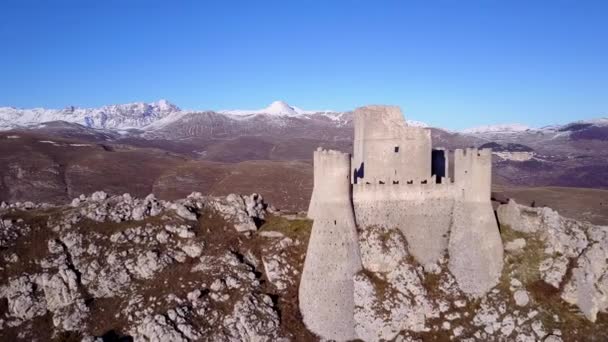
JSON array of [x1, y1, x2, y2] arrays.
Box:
[[0, 100, 608, 138]]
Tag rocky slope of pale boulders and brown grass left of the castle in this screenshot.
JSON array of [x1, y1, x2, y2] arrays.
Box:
[[0, 191, 301, 341]]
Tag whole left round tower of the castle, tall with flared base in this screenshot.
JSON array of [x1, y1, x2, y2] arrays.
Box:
[[299, 148, 361, 341]]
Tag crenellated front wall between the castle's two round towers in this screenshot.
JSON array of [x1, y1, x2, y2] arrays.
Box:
[[353, 182, 460, 265]]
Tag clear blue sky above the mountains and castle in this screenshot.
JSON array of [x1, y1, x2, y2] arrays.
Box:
[[0, 0, 608, 129]]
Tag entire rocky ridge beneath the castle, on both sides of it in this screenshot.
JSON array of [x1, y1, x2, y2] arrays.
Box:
[[0, 192, 608, 341]]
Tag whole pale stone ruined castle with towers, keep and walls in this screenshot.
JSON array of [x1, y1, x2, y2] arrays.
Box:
[[299, 106, 503, 340]]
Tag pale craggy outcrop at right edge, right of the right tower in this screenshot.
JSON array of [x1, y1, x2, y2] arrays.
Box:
[[497, 200, 608, 321]]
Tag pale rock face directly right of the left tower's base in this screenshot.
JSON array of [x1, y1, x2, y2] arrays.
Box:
[[355, 227, 439, 341]]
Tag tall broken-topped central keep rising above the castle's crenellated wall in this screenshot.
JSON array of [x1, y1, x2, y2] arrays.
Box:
[[352, 106, 431, 184]]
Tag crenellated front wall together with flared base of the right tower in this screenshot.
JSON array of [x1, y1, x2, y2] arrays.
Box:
[[353, 183, 503, 296]]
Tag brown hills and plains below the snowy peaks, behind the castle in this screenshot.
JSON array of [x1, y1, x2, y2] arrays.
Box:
[[0, 112, 608, 224]]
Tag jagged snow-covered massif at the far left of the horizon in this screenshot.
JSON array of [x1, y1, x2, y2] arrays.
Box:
[[0, 100, 180, 129]]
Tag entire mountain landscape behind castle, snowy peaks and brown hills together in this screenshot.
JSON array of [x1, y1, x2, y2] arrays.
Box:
[[0, 100, 608, 222]]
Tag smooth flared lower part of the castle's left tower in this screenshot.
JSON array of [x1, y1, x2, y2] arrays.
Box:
[[299, 202, 361, 341]]
